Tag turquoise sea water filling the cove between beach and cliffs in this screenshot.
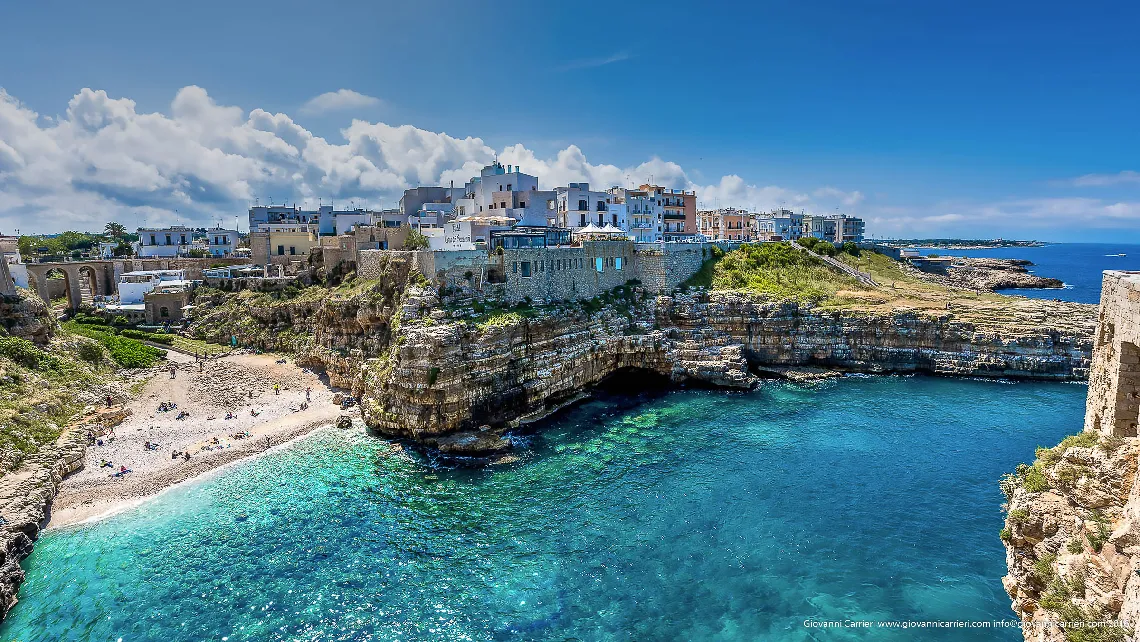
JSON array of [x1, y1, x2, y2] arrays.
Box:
[[0, 376, 1085, 642]]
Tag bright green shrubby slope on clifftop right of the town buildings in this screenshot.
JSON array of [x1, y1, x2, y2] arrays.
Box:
[[711, 243, 860, 302]]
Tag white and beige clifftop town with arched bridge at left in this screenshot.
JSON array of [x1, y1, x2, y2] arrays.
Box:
[[0, 162, 865, 325]]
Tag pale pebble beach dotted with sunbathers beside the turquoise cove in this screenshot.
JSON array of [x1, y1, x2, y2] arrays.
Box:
[[48, 352, 341, 528]]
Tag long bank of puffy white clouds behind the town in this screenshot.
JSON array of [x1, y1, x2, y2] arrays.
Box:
[[0, 87, 884, 231]]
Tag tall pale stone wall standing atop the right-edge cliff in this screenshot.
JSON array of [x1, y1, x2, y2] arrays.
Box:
[[1084, 270, 1140, 437]]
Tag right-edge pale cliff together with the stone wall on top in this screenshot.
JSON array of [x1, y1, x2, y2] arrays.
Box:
[[1001, 271, 1140, 642]]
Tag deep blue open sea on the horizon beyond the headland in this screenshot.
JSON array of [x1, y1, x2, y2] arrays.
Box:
[[922, 243, 1140, 303]]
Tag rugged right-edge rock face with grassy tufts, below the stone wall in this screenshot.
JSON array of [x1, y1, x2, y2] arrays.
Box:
[[1001, 432, 1140, 642]]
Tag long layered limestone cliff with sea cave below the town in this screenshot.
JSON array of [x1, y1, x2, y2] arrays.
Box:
[[186, 270, 1093, 454]]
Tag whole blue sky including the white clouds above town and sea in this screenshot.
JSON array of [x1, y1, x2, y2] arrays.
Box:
[[0, 0, 1140, 243]]
